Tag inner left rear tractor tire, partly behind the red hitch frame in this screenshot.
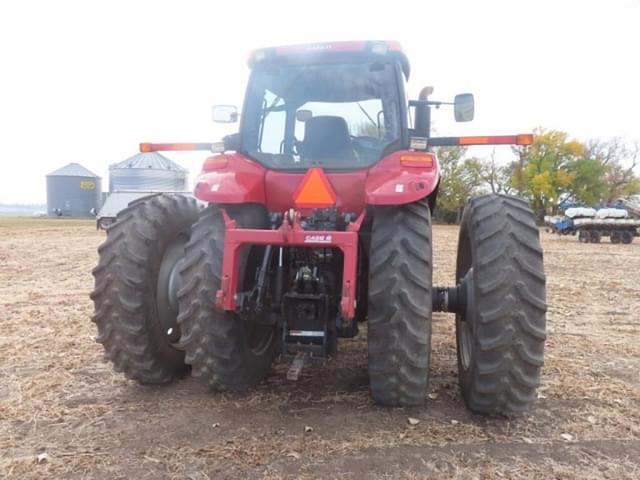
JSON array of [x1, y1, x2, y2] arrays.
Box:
[[178, 204, 277, 390]]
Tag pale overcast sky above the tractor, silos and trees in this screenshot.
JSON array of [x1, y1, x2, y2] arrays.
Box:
[[0, 0, 640, 203]]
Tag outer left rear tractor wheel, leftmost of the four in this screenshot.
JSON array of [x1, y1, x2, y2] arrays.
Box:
[[91, 194, 199, 383]]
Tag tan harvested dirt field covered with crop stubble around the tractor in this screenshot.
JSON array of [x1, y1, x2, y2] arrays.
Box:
[[0, 219, 640, 479]]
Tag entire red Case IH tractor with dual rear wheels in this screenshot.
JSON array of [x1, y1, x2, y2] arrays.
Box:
[[92, 42, 546, 415]]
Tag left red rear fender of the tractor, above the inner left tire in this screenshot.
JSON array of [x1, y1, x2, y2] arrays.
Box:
[[193, 153, 267, 205]]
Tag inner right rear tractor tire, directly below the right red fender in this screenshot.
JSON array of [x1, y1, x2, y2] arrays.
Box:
[[368, 200, 432, 406]]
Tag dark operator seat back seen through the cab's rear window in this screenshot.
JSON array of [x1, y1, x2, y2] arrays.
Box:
[[300, 115, 355, 161]]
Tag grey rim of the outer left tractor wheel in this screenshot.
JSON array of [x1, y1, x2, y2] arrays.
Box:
[[156, 235, 187, 344]]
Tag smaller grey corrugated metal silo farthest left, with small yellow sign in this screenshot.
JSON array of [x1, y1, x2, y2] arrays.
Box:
[[47, 163, 102, 217]]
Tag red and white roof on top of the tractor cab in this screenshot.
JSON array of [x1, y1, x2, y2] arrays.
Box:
[[248, 41, 410, 79]]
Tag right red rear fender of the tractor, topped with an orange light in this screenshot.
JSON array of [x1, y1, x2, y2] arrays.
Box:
[[365, 150, 440, 205]]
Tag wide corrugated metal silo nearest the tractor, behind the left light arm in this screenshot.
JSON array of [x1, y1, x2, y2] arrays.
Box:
[[109, 152, 189, 193]]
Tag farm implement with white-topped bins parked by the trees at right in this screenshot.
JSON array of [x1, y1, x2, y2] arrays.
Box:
[[545, 200, 640, 244]]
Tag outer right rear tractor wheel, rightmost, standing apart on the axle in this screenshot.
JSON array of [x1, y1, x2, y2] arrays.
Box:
[[456, 195, 546, 416]]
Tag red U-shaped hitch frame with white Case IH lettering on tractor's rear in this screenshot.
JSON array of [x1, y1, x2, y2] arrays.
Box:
[[216, 209, 365, 319]]
